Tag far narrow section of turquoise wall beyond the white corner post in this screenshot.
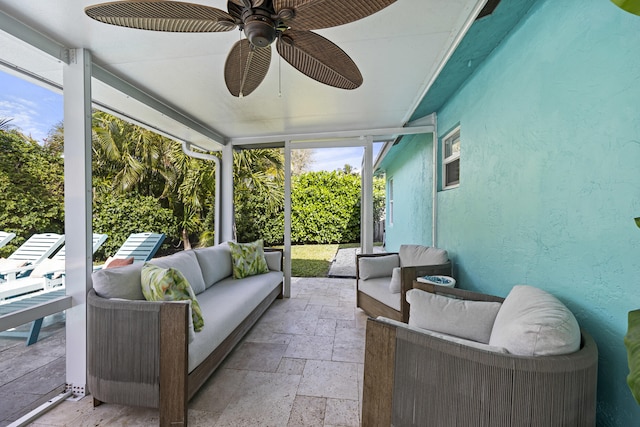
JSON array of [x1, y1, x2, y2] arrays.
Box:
[[385, 134, 433, 252]]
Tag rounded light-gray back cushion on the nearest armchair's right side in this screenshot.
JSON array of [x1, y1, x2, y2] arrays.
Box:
[[489, 285, 580, 356]]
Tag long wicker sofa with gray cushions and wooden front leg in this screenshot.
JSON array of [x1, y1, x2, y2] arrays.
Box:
[[87, 243, 283, 426]]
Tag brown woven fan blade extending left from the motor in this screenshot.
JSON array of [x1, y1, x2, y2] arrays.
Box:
[[84, 0, 236, 33]]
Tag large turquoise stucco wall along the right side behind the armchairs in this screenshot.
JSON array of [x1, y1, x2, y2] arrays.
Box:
[[436, 0, 640, 426]]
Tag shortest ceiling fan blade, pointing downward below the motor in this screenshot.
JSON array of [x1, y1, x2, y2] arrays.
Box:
[[224, 39, 271, 97]]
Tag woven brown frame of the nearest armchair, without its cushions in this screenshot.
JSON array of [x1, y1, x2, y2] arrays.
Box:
[[362, 282, 598, 427]]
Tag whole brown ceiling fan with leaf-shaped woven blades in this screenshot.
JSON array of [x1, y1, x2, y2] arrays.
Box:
[[85, 0, 396, 97]]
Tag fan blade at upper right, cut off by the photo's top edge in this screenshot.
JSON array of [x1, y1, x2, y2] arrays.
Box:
[[273, 0, 396, 30]]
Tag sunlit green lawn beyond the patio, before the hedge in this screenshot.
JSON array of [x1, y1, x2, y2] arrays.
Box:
[[276, 243, 360, 277]]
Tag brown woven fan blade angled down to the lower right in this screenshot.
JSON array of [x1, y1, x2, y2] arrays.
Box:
[[276, 30, 362, 89]]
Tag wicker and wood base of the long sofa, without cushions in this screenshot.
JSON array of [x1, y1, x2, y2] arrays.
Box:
[[87, 283, 282, 426]]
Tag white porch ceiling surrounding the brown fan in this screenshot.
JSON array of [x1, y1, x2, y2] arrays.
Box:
[[0, 0, 485, 148]]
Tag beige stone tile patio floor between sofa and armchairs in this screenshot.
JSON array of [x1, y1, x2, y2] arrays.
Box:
[[16, 278, 366, 427]]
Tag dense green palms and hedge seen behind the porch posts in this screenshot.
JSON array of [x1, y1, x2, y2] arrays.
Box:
[[0, 111, 384, 258]]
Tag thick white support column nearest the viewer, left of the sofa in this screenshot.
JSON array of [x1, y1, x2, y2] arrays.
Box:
[[63, 49, 92, 397]]
